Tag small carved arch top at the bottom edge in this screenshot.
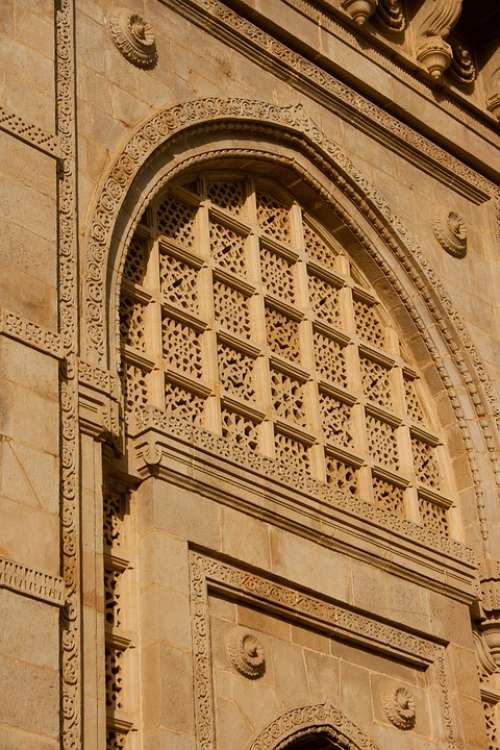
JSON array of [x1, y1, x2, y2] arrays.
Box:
[[248, 703, 378, 750]]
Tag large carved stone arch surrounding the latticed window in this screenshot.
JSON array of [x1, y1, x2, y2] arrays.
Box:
[[82, 98, 498, 552]]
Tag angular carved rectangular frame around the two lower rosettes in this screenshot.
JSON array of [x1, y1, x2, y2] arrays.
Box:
[[189, 551, 456, 750]]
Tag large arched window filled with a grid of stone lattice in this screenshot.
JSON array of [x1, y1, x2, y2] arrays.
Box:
[[120, 172, 451, 534]]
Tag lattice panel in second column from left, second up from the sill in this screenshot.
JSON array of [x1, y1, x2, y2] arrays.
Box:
[[161, 317, 203, 378]]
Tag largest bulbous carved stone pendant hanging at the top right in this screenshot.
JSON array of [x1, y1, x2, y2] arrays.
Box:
[[417, 0, 462, 81]]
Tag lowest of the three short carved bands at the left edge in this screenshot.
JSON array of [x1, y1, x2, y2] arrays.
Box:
[[0, 557, 64, 607]]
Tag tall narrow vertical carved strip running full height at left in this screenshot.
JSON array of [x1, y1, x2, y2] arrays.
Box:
[[55, 0, 81, 750]]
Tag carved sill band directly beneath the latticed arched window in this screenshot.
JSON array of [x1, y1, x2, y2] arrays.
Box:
[[133, 407, 477, 566]]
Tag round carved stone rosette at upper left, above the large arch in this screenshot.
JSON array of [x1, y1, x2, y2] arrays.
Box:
[[108, 10, 158, 68]]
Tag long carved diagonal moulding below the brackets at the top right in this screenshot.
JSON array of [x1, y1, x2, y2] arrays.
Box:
[[162, 0, 498, 203]]
